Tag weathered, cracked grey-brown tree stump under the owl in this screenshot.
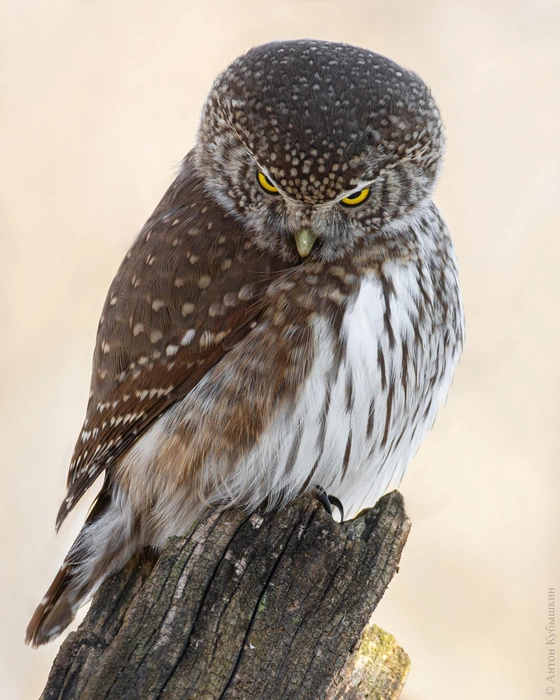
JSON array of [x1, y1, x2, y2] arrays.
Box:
[[41, 491, 410, 700]]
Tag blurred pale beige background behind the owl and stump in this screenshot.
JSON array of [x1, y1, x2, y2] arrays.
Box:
[[0, 0, 560, 700]]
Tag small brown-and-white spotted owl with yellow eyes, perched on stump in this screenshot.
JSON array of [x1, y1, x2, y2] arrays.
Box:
[[27, 40, 463, 645]]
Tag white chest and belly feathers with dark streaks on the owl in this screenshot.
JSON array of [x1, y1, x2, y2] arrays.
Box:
[[227, 265, 464, 516]]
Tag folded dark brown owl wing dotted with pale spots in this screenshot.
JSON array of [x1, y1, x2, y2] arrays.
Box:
[[57, 152, 286, 528]]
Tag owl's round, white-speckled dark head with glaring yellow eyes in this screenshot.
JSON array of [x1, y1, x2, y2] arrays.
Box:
[[196, 40, 445, 262]]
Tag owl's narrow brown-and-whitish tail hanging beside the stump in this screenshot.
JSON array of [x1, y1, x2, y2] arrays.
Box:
[[25, 490, 134, 647]]
